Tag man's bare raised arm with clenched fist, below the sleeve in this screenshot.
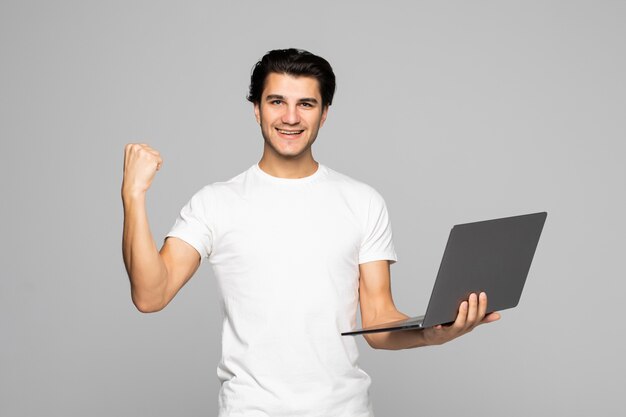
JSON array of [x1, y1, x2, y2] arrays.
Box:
[[122, 143, 200, 313]]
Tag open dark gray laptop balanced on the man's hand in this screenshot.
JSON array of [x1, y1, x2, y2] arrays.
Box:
[[341, 212, 547, 336]]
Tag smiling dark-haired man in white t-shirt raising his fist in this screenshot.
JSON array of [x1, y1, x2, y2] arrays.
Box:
[[122, 49, 499, 417]]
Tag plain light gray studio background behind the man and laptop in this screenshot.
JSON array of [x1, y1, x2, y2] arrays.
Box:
[[0, 0, 626, 417]]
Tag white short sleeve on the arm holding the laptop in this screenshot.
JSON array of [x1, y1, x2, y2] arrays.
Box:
[[359, 191, 398, 264]]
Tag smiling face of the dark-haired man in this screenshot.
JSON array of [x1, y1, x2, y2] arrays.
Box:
[[254, 73, 328, 159]]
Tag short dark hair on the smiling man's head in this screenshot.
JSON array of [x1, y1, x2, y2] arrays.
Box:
[[247, 48, 335, 106]]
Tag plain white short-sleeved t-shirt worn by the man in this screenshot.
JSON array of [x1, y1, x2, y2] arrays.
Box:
[[167, 164, 397, 417]]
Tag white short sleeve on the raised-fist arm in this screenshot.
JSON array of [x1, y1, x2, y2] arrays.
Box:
[[166, 186, 213, 262]]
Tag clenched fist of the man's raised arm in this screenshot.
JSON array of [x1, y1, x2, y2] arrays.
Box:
[[122, 143, 163, 196]]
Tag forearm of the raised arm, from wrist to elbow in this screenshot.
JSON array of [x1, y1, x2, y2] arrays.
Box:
[[122, 192, 167, 312]]
